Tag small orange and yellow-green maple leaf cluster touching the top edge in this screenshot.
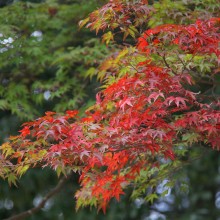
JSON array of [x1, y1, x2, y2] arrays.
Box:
[[79, 0, 154, 42]]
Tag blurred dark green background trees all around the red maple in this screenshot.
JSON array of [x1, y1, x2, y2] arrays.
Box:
[[0, 0, 220, 220]]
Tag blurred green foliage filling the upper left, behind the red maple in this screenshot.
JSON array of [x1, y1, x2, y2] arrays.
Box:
[[0, 0, 108, 120]]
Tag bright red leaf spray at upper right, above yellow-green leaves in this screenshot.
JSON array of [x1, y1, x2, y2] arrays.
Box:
[[138, 18, 220, 58]]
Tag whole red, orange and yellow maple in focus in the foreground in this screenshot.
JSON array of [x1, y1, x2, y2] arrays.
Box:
[[0, 0, 220, 217]]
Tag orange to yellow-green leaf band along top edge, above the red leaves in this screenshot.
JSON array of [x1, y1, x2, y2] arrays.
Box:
[[79, 0, 219, 43]]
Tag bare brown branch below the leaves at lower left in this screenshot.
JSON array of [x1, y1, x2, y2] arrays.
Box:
[[4, 174, 71, 220]]
